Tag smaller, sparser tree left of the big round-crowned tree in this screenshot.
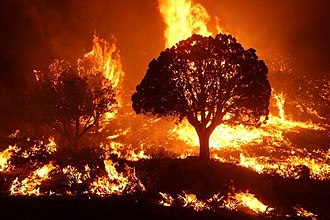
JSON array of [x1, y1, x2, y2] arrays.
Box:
[[36, 61, 117, 148]]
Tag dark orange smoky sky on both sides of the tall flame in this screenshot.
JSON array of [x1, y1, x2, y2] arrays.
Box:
[[0, 0, 330, 92]]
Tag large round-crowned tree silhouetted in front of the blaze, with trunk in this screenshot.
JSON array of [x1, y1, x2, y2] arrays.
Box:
[[132, 34, 271, 160]]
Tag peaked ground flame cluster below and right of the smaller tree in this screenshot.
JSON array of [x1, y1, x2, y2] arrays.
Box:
[[90, 160, 146, 196]]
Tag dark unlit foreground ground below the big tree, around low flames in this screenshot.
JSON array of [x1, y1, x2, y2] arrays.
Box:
[[0, 158, 330, 220]]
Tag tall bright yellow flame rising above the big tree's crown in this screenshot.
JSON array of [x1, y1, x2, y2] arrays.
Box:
[[158, 0, 223, 47]]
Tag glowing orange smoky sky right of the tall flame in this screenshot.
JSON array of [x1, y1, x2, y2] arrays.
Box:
[[201, 0, 330, 78]]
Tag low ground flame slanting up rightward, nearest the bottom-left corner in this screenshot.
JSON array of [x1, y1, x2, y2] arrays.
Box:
[[10, 161, 56, 196]]
